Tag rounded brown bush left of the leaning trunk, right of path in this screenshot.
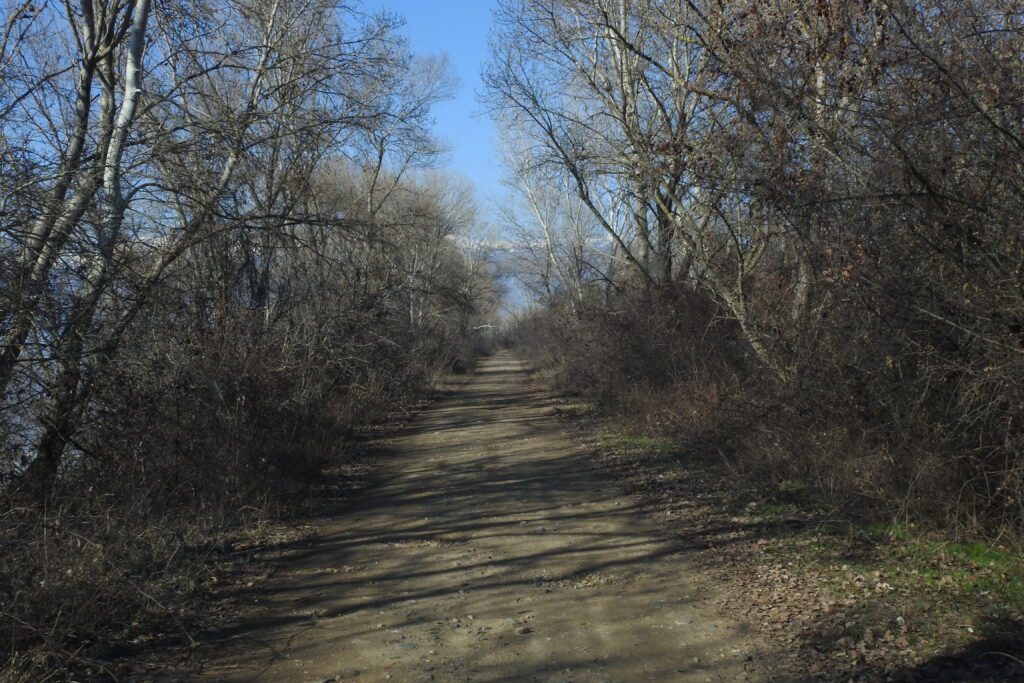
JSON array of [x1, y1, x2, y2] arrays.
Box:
[[510, 285, 750, 436]]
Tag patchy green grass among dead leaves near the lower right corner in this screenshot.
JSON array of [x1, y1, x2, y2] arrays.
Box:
[[755, 518, 1024, 657]]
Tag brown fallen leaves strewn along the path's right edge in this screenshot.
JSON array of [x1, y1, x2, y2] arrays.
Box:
[[568, 405, 1024, 683]]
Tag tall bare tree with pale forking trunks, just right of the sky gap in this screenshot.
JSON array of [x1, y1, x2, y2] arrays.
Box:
[[486, 1, 807, 377]]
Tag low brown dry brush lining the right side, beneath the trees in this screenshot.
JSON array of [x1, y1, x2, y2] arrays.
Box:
[[514, 255, 1024, 536]]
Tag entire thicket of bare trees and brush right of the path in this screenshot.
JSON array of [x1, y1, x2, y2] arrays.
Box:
[[485, 0, 1024, 532]]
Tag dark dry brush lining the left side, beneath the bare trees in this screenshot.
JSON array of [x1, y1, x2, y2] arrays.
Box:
[[0, 178, 489, 680]]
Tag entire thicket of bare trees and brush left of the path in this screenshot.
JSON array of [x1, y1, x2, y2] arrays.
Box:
[[0, 0, 493, 680]]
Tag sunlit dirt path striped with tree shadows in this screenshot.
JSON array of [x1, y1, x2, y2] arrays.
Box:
[[174, 353, 755, 682]]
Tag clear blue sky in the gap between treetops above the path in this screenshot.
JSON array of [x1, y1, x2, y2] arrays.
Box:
[[374, 0, 502, 208]]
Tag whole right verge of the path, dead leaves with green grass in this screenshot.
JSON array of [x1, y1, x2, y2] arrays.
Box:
[[556, 409, 1024, 683]]
